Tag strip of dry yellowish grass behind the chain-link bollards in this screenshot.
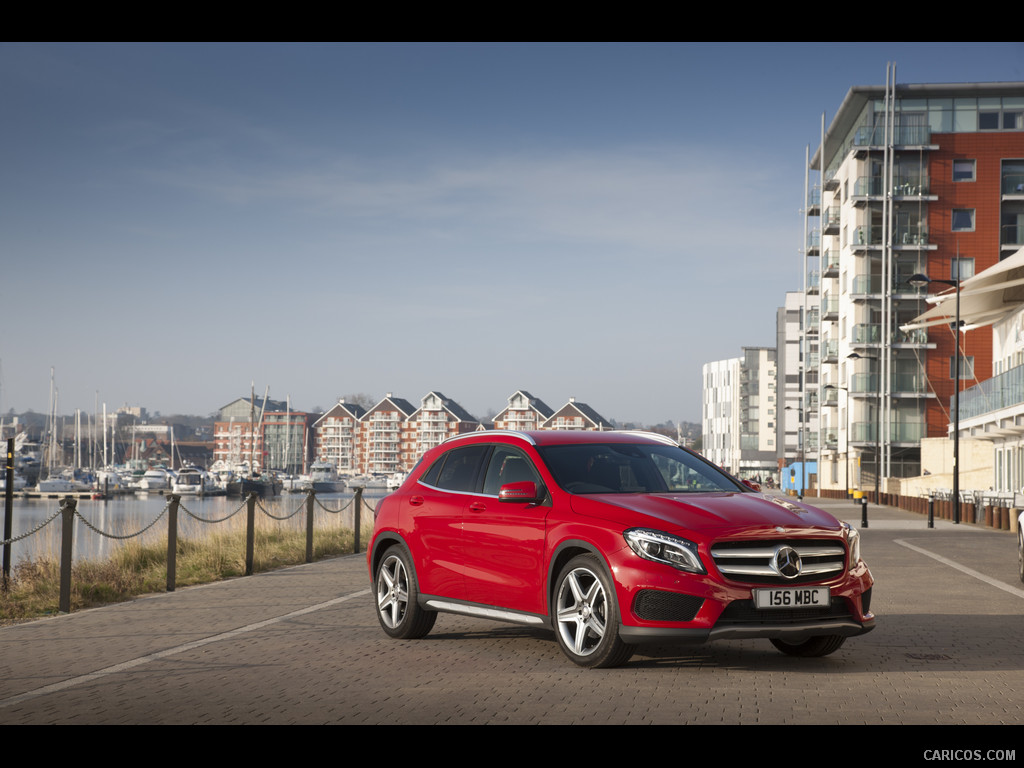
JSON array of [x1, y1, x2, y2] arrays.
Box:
[[0, 518, 369, 625]]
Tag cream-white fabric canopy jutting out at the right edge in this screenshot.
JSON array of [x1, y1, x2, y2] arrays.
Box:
[[901, 248, 1024, 331]]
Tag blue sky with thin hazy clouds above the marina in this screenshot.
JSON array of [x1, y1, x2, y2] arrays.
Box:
[[0, 43, 1024, 425]]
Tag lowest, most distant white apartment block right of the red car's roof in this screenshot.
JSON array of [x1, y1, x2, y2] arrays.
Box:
[[701, 347, 778, 481]]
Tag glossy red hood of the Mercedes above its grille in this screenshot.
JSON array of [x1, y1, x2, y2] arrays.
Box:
[[572, 493, 840, 532]]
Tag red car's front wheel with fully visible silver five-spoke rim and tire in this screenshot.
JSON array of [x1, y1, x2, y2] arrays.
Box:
[[552, 555, 636, 668]]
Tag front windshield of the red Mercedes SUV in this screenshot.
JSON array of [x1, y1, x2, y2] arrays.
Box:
[[538, 444, 746, 494]]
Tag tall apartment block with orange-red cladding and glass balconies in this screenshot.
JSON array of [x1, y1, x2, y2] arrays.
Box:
[[802, 78, 1024, 492]]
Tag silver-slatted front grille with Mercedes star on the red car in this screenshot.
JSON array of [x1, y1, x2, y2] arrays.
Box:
[[711, 539, 846, 584]]
